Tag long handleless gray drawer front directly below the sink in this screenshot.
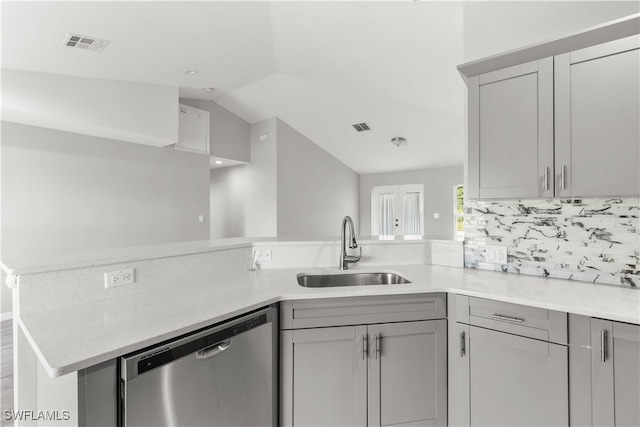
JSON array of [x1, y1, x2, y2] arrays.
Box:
[[280, 293, 447, 329]]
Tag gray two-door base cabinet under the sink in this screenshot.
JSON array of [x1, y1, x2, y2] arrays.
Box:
[[280, 297, 447, 426]]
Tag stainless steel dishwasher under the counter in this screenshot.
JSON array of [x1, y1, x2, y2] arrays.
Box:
[[118, 307, 278, 427]]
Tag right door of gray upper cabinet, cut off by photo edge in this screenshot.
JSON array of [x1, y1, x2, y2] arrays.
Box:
[[555, 36, 640, 197]]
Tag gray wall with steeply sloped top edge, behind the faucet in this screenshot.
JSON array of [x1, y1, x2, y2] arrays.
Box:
[[278, 120, 359, 237]]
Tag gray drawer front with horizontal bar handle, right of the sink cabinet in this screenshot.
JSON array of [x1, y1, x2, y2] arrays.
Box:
[[458, 297, 567, 344]]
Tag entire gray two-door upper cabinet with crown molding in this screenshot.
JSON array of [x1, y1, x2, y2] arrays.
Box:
[[458, 15, 640, 199]]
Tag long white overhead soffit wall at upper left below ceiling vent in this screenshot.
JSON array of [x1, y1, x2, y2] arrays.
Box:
[[2, 69, 178, 147]]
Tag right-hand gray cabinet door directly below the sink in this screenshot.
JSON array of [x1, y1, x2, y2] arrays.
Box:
[[368, 320, 447, 426]]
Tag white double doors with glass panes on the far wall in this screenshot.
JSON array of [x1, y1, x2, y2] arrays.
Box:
[[371, 184, 424, 236]]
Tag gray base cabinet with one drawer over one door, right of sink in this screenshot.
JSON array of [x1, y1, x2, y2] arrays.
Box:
[[449, 296, 569, 426]]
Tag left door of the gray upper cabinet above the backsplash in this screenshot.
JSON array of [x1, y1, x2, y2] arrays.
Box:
[[465, 58, 553, 199]]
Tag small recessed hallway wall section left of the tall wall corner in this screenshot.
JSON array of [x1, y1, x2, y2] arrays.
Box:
[[209, 165, 247, 239]]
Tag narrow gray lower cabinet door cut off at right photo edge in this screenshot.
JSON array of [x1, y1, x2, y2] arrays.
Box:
[[591, 319, 640, 426]]
